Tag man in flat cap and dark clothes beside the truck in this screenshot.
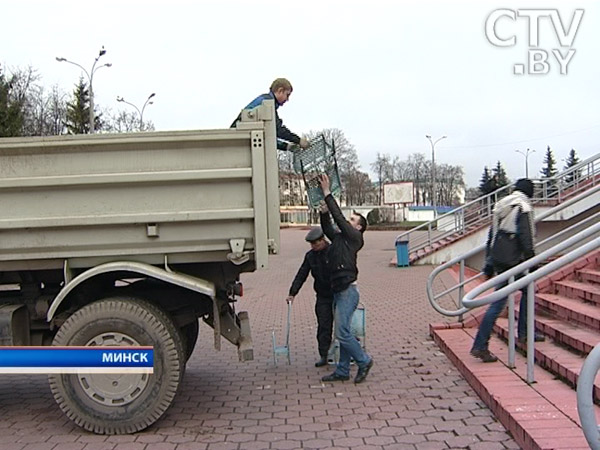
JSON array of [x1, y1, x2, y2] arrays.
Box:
[[286, 227, 333, 367]]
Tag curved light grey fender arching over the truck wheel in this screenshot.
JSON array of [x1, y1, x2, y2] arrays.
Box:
[[46, 261, 215, 322]]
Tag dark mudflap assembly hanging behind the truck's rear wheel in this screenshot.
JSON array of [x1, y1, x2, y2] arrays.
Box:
[[204, 297, 254, 362]]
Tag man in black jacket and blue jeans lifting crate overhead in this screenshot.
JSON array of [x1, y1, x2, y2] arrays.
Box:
[[319, 174, 373, 384]]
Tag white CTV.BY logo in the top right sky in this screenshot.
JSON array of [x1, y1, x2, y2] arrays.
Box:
[[485, 9, 584, 75]]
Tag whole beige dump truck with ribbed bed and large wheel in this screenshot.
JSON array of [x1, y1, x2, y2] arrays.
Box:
[[0, 101, 280, 434]]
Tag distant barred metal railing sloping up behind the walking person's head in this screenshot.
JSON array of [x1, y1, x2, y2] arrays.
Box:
[[396, 153, 600, 262]]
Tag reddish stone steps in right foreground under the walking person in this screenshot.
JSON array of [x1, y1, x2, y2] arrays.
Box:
[[430, 250, 600, 449]]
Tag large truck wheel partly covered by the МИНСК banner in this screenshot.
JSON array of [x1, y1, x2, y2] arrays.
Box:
[[48, 297, 185, 434]]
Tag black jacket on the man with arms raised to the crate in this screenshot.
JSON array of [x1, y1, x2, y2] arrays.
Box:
[[321, 194, 364, 292]]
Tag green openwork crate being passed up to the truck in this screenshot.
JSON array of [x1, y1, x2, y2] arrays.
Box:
[[294, 136, 342, 208]]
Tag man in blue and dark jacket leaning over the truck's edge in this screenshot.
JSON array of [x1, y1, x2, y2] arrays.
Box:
[[231, 78, 309, 150]]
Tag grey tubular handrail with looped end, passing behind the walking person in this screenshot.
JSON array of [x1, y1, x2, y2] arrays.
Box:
[[426, 185, 600, 317]]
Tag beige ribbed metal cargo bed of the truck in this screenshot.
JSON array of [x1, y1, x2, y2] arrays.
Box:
[[0, 102, 279, 271]]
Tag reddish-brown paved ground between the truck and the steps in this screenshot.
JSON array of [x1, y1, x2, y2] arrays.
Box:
[[0, 229, 518, 450]]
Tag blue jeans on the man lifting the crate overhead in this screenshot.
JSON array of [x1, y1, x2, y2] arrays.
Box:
[[333, 284, 371, 377]]
